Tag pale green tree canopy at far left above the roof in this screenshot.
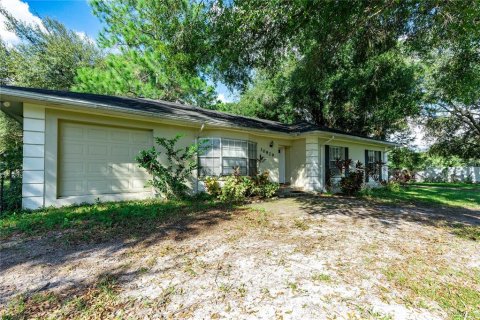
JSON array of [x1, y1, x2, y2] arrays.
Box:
[[0, 6, 102, 90]]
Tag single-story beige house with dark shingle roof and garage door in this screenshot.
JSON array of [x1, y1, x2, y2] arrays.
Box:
[[0, 86, 395, 209]]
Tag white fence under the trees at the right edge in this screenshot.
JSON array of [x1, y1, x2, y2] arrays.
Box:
[[415, 167, 480, 183]]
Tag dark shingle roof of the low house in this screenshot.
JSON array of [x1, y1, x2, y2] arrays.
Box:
[[0, 86, 394, 141]]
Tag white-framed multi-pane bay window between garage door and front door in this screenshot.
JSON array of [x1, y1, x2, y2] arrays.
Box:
[[198, 138, 257, 176]]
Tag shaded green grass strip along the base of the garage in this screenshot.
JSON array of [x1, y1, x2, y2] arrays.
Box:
[[0, 199, 219, 240]]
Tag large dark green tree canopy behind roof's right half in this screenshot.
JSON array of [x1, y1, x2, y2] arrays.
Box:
[[210, 0, 480, 143]]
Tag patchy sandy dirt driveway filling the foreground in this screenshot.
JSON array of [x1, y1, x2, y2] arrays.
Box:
[[0, 197, 480, 319]]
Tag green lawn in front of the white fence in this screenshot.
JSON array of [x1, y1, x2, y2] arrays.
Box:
[[362, 183, 480, 209]]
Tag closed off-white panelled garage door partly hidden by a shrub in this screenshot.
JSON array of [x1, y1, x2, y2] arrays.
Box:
[[58, 122, 153, 197]]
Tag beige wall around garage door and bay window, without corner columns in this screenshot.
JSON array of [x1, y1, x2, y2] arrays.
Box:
[[34, 104, 292, 209]]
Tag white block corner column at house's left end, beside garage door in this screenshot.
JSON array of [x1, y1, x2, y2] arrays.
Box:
[[22, 103, 45, 210]]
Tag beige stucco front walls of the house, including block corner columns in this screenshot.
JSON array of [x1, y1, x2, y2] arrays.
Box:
[[23, 103, 392, 209]]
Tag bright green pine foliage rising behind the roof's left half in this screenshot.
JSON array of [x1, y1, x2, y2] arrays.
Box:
[[74, 0, 216, 107]]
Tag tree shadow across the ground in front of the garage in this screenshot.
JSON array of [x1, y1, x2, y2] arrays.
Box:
[[0, 203, 242, 302]]
